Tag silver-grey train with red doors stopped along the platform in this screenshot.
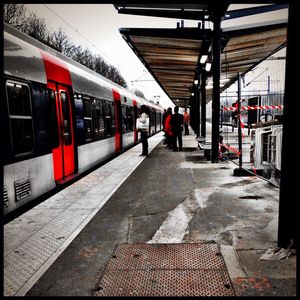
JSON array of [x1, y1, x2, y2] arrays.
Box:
[[1, 24, 163, 215]]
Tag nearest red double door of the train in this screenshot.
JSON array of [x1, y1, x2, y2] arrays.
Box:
[[48, 82, 75, 181]]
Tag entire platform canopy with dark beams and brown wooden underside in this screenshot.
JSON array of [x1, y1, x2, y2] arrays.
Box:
[[115, 4, 287, 107]]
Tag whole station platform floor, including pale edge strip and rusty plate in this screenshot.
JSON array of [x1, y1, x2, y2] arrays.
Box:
[[4, 127, 296, 296]]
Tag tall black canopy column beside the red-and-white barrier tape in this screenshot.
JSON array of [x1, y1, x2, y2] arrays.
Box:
[[211, 14, 221, 163]]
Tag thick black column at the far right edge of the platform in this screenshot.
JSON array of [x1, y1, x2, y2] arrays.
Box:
[[278, 1, 300, 249]]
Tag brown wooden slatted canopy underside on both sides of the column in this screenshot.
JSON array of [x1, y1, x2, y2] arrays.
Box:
[[120, 22, 287, 106]]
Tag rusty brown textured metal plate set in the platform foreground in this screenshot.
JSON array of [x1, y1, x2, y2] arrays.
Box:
[[95, 243, 234, 296]]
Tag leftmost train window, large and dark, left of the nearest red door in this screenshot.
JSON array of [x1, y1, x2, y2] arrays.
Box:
[[6, 81, 33, 156]]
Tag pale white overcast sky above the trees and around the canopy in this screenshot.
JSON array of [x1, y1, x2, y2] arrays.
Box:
[[25, 4, 287, 107]]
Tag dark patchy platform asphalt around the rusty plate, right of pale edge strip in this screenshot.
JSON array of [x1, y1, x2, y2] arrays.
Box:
[[5, 130, 296, 296]]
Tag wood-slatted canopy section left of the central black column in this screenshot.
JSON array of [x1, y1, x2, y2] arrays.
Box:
[[120, 28, 211, 106]]
